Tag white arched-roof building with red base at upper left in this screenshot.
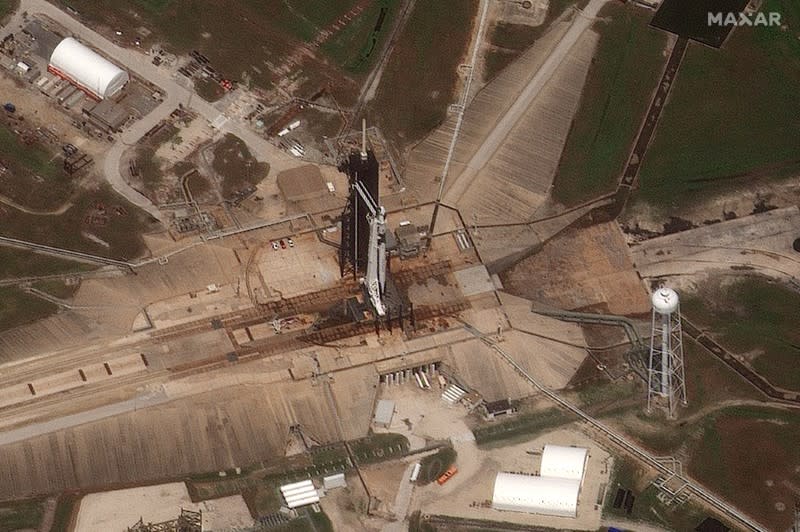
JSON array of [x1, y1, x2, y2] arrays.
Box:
[[47, 37, 130, 100]]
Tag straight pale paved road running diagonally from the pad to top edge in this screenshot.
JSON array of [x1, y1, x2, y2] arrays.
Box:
[[445, 0, 609, 205]]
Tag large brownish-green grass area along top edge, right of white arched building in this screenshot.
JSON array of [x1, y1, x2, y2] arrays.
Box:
[[63, 0, 399, 102]]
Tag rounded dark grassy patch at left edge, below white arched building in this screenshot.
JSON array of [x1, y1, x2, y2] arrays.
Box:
[[0, 124, 73, 210]]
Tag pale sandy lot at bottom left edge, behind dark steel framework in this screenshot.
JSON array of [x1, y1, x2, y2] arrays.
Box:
[[74, 482, 253, 532]]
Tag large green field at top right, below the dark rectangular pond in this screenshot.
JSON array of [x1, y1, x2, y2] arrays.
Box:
[[637, 0, 800, 209]]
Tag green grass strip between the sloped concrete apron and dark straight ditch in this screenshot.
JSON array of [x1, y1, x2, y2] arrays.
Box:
[[553, 3, 667, 206]]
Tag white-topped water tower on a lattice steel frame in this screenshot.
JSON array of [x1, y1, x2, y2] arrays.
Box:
[[647, 287, 686, 418]]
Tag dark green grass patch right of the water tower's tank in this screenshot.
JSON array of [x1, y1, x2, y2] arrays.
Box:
[[683, 277, 800, 391]]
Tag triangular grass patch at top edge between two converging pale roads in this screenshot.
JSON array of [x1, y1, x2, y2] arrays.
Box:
[[483, 0, 588, 80]]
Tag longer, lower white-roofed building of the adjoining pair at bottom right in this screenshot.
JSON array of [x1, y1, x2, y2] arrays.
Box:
[[492, 473, 581, 517]]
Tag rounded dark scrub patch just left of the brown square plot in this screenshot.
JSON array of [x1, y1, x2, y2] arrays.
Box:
[[213, 133, 269, 198]]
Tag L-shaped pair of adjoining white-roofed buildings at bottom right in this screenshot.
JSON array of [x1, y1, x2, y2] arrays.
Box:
[[492, 445, 589, 517]]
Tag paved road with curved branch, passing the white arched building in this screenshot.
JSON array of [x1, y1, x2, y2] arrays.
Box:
[[0, 0, 301, 223]]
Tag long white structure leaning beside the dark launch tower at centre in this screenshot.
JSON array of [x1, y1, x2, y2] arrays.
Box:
[[353, 181, 386, 317]]
